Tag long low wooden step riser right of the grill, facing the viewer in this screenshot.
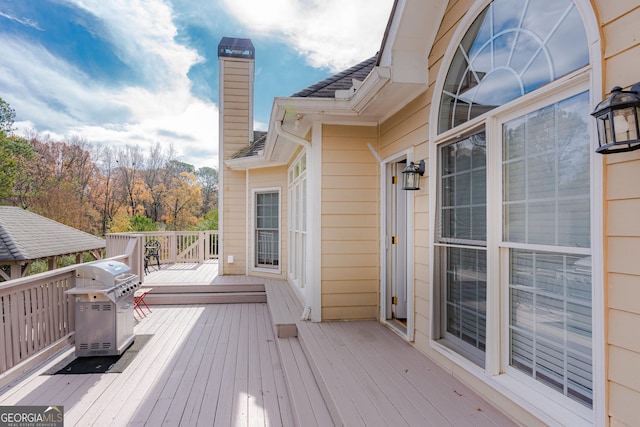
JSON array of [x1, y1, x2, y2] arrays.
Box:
[[145, 289, 267, 305]]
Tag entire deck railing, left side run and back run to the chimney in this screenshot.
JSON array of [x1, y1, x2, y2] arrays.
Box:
[[0, 231, 218, 387]]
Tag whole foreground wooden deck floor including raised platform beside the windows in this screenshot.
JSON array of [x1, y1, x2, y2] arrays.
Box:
[[0, 262, 515, 427]]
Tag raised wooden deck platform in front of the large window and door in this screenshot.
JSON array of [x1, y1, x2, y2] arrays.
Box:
[[298, 321, 515, 427]]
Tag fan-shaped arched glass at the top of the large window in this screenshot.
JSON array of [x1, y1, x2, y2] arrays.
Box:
[[438, 0, 589, 133]]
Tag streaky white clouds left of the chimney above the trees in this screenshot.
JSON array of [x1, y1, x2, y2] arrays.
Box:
[[0, 0, 218, 171]]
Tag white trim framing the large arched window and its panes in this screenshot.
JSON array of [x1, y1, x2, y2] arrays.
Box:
[[428, 0, 607, 424]]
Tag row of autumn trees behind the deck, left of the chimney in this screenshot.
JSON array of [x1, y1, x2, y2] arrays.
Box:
[[0, 98, 218, 235]]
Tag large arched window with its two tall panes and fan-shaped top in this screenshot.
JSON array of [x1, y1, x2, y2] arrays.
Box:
[[432, 0, 594, 420]]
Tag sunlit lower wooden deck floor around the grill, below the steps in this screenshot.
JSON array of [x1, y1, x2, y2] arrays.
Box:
[[0, 304, 292, 426]]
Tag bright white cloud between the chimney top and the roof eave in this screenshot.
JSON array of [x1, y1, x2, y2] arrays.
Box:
[[223, 0, 393, 72]]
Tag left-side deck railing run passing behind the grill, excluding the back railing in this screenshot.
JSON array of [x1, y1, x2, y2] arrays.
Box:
[[0, 236, 144, 387]]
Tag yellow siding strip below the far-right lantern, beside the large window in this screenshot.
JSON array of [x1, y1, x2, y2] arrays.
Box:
[[605, 158, 640, 425]]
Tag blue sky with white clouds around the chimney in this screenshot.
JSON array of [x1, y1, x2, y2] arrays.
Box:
[[0, 0, 393, 168]]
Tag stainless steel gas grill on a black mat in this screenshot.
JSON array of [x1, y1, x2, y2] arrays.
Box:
[[67, 260, 140, 357]]
